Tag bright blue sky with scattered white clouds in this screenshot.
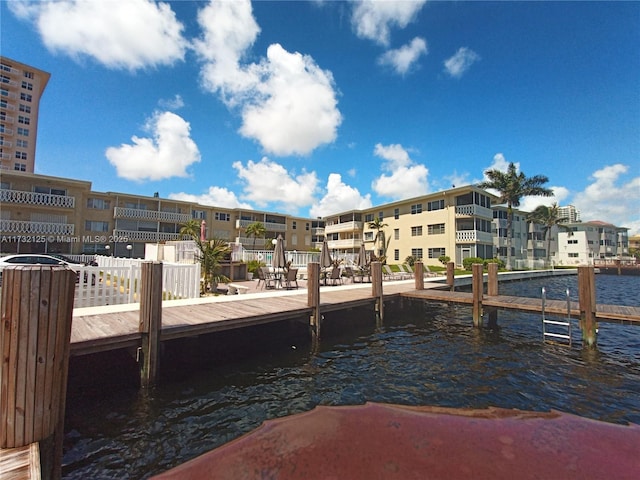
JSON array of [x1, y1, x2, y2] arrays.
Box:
[[0, 0, 640, 234]]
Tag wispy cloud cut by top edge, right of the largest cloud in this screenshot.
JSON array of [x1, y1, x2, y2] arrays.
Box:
[[351, 0, 426, 46]]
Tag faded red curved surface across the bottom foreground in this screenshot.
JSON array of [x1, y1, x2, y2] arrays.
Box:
[[154, 403, 640, 480]]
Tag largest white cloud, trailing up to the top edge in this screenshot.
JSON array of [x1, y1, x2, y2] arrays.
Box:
[[195, 1, 342, 156]]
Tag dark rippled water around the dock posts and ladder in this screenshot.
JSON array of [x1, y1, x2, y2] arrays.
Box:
[[63, 275, 640, 479]]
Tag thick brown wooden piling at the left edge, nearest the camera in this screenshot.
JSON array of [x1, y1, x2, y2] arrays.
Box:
[[0, 266, 77, 479]]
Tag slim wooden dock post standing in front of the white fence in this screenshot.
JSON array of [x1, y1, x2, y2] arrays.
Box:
[[139, 262, 162, 388]]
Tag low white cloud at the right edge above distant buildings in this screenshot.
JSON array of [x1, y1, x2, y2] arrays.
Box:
[[572, 163, 640, 234]]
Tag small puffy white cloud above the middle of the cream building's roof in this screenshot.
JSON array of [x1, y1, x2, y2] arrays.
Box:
[[371, 144, 429, 200]]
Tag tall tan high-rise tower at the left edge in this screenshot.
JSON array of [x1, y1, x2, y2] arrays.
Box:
[[0, 56, 51, 172]]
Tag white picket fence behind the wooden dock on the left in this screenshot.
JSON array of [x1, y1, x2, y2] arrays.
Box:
[[74, 256, 200, 308]]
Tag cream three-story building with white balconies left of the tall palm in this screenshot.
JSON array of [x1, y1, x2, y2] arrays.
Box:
[[324, 185, 496, 265]]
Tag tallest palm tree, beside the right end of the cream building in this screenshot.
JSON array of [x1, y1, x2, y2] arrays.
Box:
[[477, 162, 553, 270]]
